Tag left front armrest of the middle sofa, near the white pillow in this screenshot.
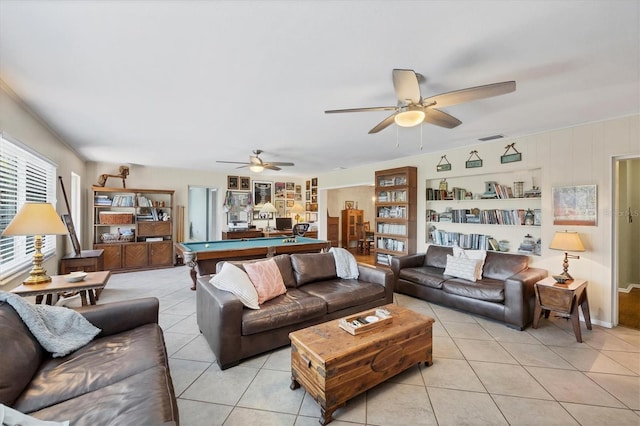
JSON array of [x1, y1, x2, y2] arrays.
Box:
[[196, 277, 244, 369]]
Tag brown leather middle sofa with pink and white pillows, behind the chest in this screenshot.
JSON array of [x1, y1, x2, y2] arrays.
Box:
[[196, 253, 393, 370]]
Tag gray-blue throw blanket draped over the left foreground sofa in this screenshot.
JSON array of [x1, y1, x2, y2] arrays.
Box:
[[0, 291, 100, 358]]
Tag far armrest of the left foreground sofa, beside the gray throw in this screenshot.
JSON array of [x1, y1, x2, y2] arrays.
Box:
[[76, 297, 160, 337]]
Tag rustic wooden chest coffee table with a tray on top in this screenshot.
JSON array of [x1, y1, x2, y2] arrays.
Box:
[[289, 305, 434, 425]]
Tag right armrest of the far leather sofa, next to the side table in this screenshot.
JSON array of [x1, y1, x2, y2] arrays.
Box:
[[504, 268, 549, 330]]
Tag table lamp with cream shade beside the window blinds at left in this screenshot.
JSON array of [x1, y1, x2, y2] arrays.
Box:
[[2, 203, 68, 284]]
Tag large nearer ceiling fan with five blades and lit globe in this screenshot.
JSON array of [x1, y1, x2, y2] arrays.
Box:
[[325, 69, 516, 133]]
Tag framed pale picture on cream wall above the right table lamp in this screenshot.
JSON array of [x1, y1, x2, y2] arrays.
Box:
[[552, 185, 598, 226]]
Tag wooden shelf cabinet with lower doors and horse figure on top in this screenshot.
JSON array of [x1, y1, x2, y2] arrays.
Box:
[[93, 186, 174, 272]]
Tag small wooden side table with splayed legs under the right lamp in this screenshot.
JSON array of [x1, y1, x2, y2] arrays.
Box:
[[533, 277, 591, 343]]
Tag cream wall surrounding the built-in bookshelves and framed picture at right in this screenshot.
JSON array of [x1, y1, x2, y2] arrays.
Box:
[[318, 114, 640, 326]]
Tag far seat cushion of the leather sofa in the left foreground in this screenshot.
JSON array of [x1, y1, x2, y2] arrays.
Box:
[[14, 324, 168, 414]]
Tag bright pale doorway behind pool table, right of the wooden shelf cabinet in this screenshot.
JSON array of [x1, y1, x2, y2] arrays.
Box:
[[188, 186, 218, 241]]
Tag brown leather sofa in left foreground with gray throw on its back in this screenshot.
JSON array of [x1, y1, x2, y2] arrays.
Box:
[[0, 298, 179, 426]]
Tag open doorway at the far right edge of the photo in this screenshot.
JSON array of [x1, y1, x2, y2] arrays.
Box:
[[613, 157, 640, 329]]
